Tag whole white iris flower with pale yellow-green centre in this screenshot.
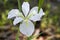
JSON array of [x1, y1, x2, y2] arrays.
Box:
[[8, 2, 44, 37]]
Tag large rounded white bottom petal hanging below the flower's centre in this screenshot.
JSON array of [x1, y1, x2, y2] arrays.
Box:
[[20, 21, 34, 37]]
